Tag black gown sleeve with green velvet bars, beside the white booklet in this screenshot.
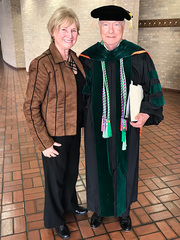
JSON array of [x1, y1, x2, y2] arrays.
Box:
[[132, 52, 164, 125]]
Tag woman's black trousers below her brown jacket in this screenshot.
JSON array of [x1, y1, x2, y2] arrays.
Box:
[[42, 128, 81, 228]]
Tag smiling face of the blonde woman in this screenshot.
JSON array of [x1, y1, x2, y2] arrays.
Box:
[[52, 21, 78, 52]]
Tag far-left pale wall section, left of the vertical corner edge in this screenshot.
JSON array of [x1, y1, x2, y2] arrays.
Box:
[[0, 0, 25, 68]]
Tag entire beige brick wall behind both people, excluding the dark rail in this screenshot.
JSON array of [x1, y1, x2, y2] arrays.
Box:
[[0, 0, 180, 89]]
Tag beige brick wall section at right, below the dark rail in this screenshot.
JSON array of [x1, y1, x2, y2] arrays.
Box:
[[139, 27, 180, 89]]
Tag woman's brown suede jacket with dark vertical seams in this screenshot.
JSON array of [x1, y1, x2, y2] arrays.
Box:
[[23, 43, 85, 151]]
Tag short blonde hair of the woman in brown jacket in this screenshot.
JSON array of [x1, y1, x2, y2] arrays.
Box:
[[47, 7, 80, 37]]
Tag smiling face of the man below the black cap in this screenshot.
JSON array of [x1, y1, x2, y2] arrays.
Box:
[[99, 21, 124, 51]]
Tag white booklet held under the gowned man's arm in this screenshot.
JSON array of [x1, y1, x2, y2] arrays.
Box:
[[125, 81, 144, 121]]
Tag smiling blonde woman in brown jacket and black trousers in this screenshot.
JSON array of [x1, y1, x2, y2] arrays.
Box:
[[24, 7, 87, 239]]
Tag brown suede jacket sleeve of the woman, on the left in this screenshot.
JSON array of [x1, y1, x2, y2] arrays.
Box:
[[23, 58, 54, 151]]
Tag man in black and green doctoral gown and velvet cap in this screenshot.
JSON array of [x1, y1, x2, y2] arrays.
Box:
[[80, 5, 164, 231]]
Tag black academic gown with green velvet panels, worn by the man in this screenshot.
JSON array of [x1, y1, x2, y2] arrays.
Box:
[[80, 40, 164, 217]]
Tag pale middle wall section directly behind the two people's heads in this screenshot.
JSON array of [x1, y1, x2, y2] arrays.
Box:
[[21, 0, 139, 69]]
